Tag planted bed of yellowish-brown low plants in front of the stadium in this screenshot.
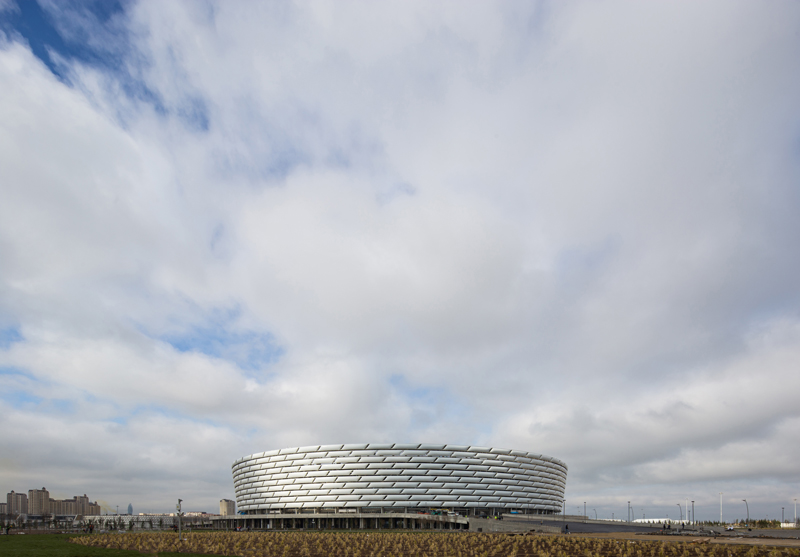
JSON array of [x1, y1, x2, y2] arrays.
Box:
[[71, 532, 800, 557]]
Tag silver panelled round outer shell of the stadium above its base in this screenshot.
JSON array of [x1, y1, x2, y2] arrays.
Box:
[[232, 443, 567, 515]]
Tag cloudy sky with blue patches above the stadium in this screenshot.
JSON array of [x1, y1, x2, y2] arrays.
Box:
[[0, 0, 800, 520]]
